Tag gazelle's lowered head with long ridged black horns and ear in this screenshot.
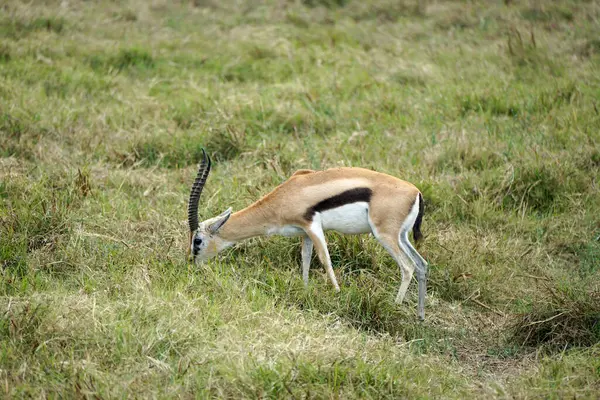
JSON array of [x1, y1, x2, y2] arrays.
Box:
[[188, 149, 231, 262]]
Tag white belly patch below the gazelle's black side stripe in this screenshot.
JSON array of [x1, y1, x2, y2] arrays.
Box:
[[318, 202, 371, 234]]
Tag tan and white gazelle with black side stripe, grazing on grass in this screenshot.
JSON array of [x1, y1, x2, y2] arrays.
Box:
[[188, 150, 427, 319]]
